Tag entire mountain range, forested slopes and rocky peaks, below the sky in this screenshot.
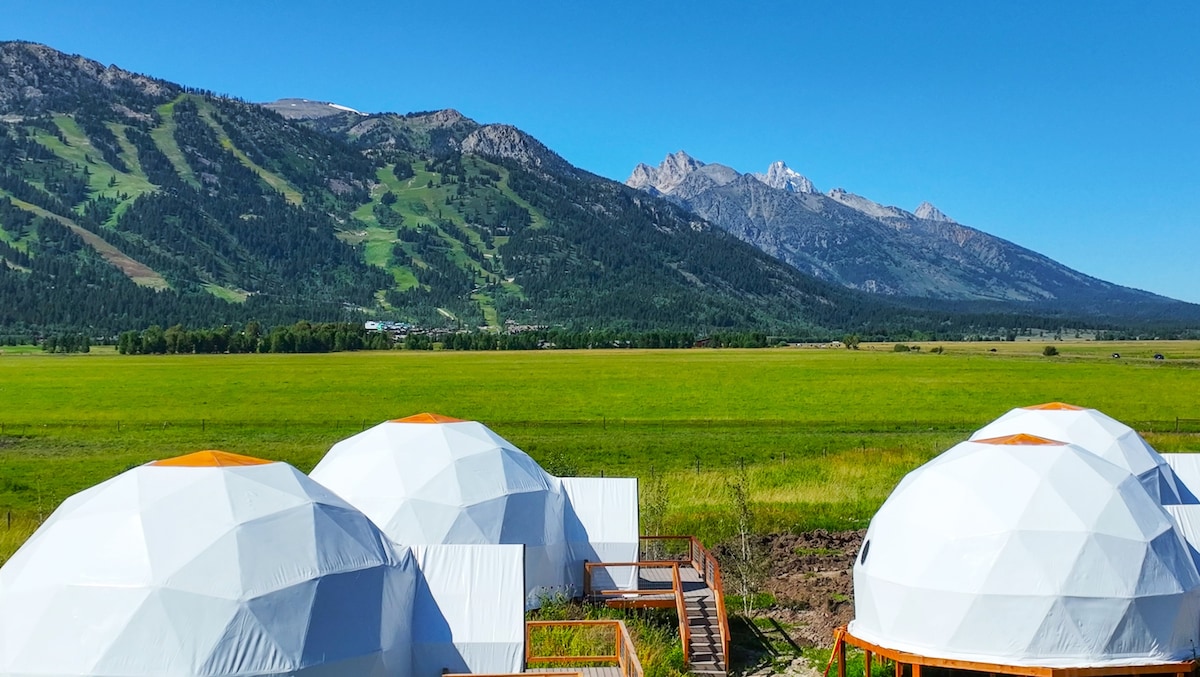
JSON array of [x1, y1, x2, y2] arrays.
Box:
[[0, 42, 1200, 336]]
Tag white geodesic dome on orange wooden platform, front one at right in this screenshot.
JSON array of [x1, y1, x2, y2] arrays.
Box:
[[848, 435, 1200, 667]]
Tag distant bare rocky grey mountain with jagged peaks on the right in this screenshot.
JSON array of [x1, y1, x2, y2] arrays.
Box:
[[625, 151, 1177, 313]]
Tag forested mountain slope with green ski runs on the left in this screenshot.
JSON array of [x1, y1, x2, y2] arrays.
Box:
[[0, 43, 902, 330]]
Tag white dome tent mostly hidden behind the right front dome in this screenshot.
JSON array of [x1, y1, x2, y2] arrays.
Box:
[[971, 402, 1198, 505]]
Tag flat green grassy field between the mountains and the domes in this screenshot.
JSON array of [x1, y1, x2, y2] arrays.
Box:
[[0, 342, 1200, 557]]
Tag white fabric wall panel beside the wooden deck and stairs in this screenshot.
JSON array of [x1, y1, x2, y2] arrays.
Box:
[[562, 478, 638, 592]]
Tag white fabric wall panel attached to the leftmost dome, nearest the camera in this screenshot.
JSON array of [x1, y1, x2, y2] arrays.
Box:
[[412, 545, 526, 677]]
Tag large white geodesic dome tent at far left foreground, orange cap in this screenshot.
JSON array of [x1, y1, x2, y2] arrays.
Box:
[[0, 451, 416, 677]]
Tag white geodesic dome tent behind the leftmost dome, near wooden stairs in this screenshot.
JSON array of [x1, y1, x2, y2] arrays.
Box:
[[310, 414, 571, 607]]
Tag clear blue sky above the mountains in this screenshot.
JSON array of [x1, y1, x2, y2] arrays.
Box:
[[0, 0, 1200, 302]]
